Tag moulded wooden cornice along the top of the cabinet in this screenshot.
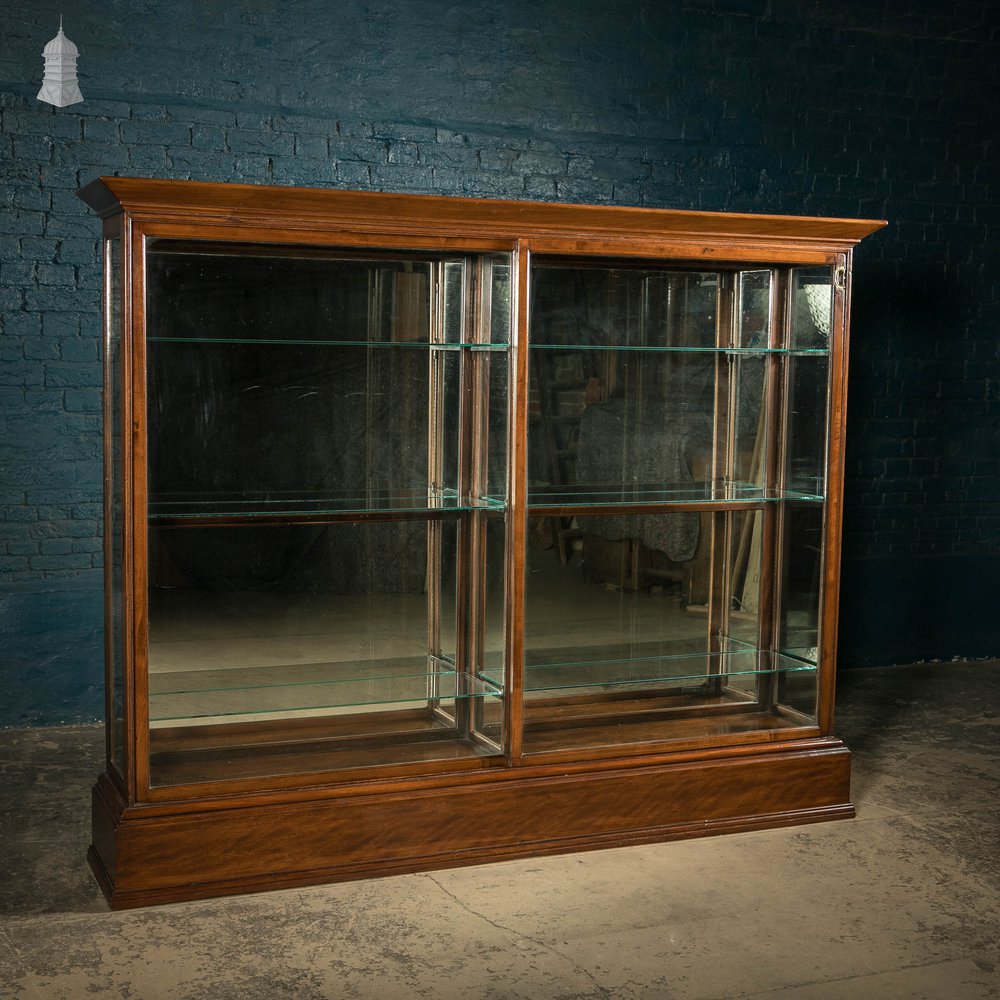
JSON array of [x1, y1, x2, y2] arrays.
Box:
[[78, 177, 886, 250]]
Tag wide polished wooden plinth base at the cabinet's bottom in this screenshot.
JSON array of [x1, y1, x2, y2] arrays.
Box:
[[89, 739, 854, 909]]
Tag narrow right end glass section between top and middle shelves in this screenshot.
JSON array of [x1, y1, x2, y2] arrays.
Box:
[[785, 355, 830, 497]]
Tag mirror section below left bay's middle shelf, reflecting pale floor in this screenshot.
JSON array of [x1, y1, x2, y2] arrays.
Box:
[[149, 521, 455, 726]]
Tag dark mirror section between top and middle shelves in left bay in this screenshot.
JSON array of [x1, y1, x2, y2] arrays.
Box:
[[149, 342, 459, 516]]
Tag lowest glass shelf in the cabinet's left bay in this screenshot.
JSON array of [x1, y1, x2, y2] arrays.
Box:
[[149, 656, 502, 725]]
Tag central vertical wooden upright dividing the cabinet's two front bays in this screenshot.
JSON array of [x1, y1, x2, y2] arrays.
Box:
[[504, 241, 531, 764]]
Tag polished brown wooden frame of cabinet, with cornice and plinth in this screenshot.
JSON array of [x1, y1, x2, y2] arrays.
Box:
[[80, 177, 882, 908]]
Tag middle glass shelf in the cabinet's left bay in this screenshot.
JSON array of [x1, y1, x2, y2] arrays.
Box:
[[149, 489, 504, 524]]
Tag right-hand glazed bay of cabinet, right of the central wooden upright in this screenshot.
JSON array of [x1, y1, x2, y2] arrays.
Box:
[[523, 259, 829, 754]]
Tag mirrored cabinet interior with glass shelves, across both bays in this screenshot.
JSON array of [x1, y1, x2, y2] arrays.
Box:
[[137, 238, 834, 786]]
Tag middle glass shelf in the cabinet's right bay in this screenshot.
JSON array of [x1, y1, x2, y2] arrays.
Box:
[[528, 482, 823, 509]]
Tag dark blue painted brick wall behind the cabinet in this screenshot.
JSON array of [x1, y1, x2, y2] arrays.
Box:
[[0, 0, 1000, 725]]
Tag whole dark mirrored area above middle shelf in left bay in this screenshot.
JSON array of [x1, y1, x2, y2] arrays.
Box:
[[147, 241, 476, 517]]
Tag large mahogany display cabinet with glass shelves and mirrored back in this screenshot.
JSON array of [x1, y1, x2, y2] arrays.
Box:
[[80, 177, 881, 907]]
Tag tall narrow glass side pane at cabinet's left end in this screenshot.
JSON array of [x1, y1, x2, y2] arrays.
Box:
[[104, 237, 125, 775]]
